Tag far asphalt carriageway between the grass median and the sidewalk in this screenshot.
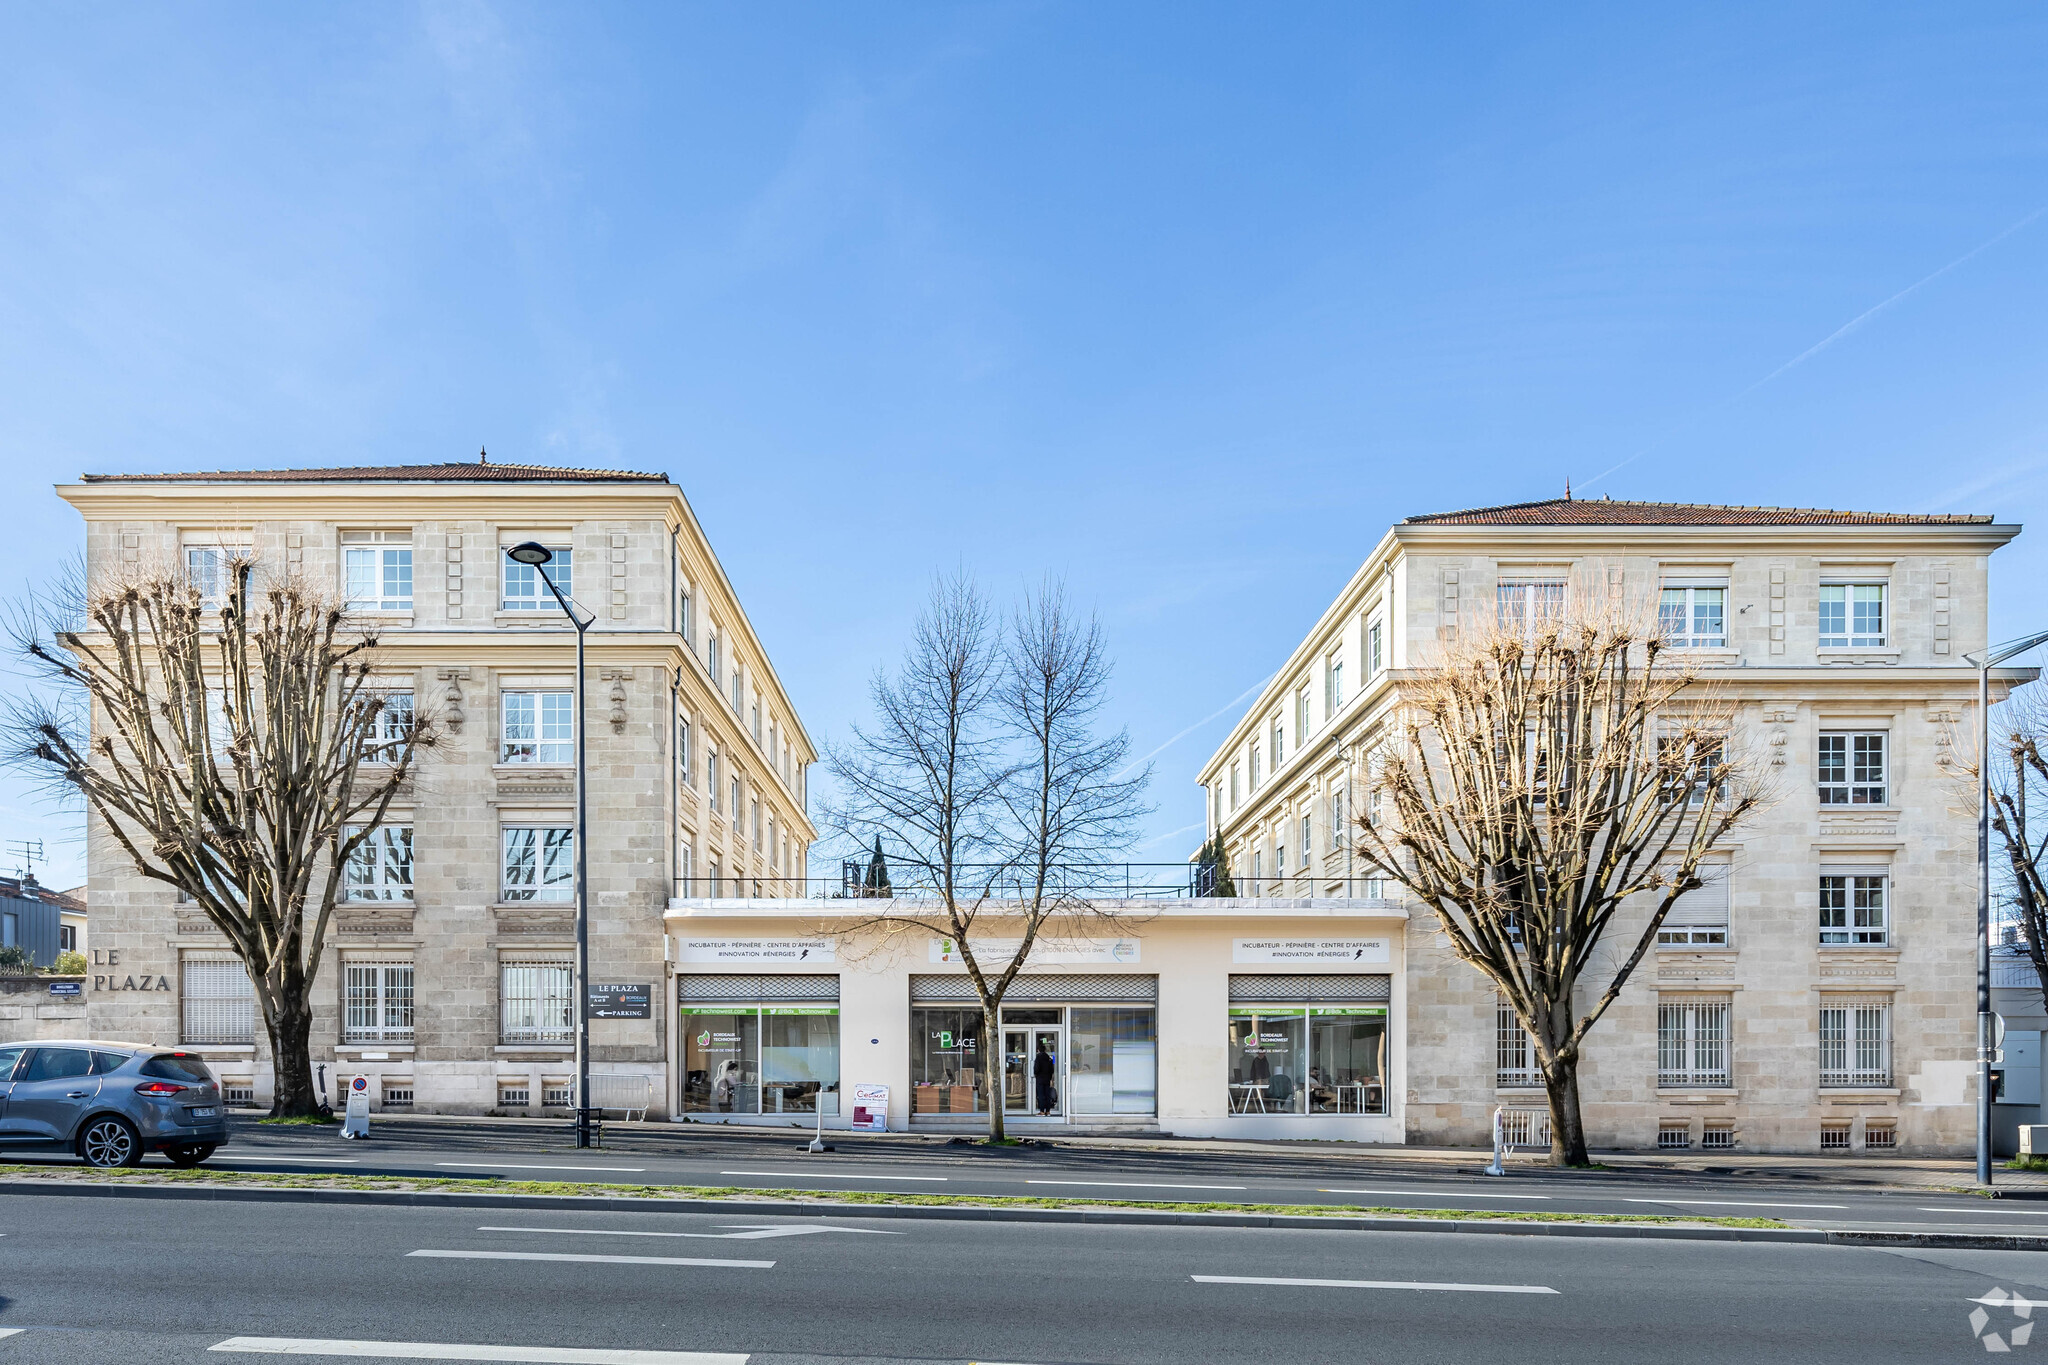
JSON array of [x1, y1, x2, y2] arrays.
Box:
[[4, 1121, 2048, 1236]]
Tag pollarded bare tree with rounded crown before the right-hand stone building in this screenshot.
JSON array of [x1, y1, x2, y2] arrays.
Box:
[[1358, 614, 1761, 1166]]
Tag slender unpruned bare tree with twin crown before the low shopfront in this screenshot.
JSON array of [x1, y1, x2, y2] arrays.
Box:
[[827, 577, 1151, 1142]]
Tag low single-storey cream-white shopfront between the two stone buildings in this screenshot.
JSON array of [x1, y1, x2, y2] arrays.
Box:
[[666, 898, 1407, 1142]]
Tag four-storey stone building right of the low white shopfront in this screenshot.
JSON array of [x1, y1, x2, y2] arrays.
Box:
[[1200, 499, 2032, 1152]]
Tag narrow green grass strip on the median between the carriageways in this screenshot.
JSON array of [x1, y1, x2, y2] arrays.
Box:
[[0, 1164, 1792, 1228]]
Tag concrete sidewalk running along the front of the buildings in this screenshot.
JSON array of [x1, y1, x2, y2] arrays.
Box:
[[247, 1111, 2048, 1197]]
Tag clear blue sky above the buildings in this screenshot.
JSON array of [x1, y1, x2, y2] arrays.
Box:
[[0, 2, 2048, 880]]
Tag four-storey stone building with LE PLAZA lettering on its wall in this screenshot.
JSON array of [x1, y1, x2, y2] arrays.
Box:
[[57, 463, 815, 1115]]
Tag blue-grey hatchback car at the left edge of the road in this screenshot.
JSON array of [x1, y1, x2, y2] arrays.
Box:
[[0, 1042, 227, 1166]]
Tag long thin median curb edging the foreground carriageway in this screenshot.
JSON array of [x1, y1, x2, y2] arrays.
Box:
[[16, 1181, 2048, 1250]]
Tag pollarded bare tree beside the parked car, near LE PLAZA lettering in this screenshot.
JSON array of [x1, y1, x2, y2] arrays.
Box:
[[8, 559, 432, 1117]]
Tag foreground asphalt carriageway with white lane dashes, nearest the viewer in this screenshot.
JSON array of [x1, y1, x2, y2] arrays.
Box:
[[0, 1197, 2048, 1365]]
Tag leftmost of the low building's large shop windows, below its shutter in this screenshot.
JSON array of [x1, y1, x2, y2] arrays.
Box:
[[682, 1005, 840, 1113]]
